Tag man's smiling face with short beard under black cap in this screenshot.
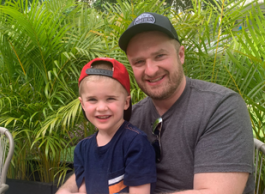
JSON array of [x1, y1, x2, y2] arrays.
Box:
[[127, 31, 185, 100]]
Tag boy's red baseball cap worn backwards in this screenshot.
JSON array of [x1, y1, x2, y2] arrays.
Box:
[[78, 57, 132, 121]]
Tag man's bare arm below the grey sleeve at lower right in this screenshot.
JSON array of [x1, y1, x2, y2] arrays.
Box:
[[171, 172, 249, 194]]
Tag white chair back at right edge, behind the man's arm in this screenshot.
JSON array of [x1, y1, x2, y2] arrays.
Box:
[[253, 138, 265, 194]]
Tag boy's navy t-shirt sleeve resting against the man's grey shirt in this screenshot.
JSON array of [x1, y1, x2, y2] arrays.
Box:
[[124, 134, 156, 186]]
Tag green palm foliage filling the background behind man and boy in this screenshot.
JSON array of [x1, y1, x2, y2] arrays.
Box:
[[0, 0, 265, 189]]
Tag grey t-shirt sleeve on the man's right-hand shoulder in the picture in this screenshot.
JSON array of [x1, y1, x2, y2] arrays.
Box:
[[194, 94, 253, 173]]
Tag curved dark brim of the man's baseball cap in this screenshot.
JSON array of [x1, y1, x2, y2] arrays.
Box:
[[119, 23, 174, 52]]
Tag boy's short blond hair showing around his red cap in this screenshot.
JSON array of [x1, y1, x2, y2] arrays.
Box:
[[79, 61, 129, 96]]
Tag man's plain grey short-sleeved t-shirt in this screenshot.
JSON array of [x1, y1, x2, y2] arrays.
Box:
[[130, 77, 254, 193]]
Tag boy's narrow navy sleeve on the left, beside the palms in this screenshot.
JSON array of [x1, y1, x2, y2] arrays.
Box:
[[74, 142, 85, 188]]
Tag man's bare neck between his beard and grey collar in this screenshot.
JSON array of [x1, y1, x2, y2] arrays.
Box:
[[152, 76, 186, 116]]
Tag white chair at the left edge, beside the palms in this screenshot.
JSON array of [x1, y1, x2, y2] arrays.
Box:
[[0, 127, 14, 194]]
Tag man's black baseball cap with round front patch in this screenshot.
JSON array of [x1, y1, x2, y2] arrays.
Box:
[[119, 12, 179, 52]]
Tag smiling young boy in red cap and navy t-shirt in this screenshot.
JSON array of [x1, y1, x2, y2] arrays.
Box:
[[74, 58, 156, 194]]
